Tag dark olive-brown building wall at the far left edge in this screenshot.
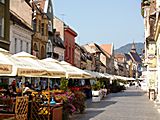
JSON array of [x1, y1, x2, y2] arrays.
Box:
[[0, 0, 10, 50]]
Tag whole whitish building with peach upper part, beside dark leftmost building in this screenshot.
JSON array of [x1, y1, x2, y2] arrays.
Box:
[[10, 0, 33, 54]]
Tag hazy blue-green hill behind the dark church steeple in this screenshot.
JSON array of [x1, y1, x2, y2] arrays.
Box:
[[114, 43, 144, 54]]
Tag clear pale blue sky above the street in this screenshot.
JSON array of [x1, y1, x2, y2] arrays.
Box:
[[53, 0, 144, 48]]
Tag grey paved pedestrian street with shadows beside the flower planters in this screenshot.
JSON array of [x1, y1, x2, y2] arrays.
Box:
[[72, 87, 160, 120]]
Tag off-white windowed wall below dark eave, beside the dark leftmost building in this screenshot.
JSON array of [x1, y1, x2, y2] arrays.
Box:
[[10, 22, 33, 54]]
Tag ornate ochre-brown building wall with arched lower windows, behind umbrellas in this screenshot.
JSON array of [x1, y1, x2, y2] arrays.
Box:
[[32, 10, 48, 59]]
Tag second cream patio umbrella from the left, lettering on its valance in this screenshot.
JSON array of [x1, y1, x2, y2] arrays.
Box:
[[12, 52, 48, 77]]
